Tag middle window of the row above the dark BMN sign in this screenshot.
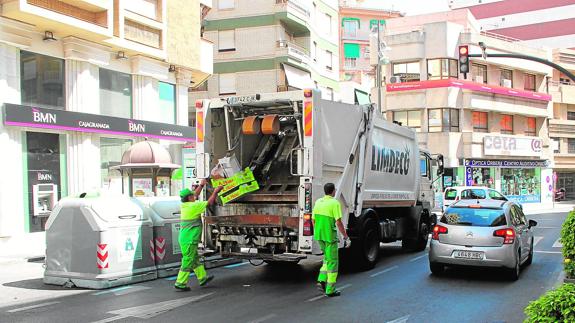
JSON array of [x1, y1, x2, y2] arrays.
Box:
[[99, 68, 132, 118]]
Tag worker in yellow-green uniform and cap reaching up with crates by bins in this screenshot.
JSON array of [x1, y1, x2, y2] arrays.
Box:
[[174, 179, 222, 291]]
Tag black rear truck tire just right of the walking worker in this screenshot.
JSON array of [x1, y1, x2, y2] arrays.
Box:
[[351, 218, 379, 270]]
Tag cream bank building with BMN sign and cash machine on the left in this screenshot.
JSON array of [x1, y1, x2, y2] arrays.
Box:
[[0, 0, 213, 254]]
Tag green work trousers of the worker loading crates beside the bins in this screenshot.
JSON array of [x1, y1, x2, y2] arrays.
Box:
[[176, 226, 207, 287]]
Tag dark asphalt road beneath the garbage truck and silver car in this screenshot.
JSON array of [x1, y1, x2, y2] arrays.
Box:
[[0, 213, 566, 323]]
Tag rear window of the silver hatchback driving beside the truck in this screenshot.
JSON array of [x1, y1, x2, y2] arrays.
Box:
[[440, 207, 507, 227]]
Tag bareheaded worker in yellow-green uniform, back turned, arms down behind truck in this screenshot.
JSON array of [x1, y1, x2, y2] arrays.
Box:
[[312, 183, 351, 297]]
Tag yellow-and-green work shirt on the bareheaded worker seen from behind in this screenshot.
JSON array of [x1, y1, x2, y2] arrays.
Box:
[[312, 195, 341, 242]]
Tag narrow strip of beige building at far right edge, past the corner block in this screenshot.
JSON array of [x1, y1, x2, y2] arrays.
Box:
[[549, 49, 575, 199]]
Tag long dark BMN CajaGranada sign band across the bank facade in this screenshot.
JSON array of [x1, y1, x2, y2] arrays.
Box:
[[4, 104, 196, 141]]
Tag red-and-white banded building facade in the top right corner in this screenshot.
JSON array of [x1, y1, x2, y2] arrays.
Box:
[[449, 0, 575, 49]]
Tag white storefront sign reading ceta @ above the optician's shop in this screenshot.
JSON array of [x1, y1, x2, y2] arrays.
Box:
[[483, 136, 543, 157]]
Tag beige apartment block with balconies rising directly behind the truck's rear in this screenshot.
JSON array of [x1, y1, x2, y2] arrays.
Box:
[[190, 0, 339, 104]]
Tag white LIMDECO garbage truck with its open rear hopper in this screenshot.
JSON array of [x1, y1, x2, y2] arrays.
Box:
[[195, 90, 443, 269]]
